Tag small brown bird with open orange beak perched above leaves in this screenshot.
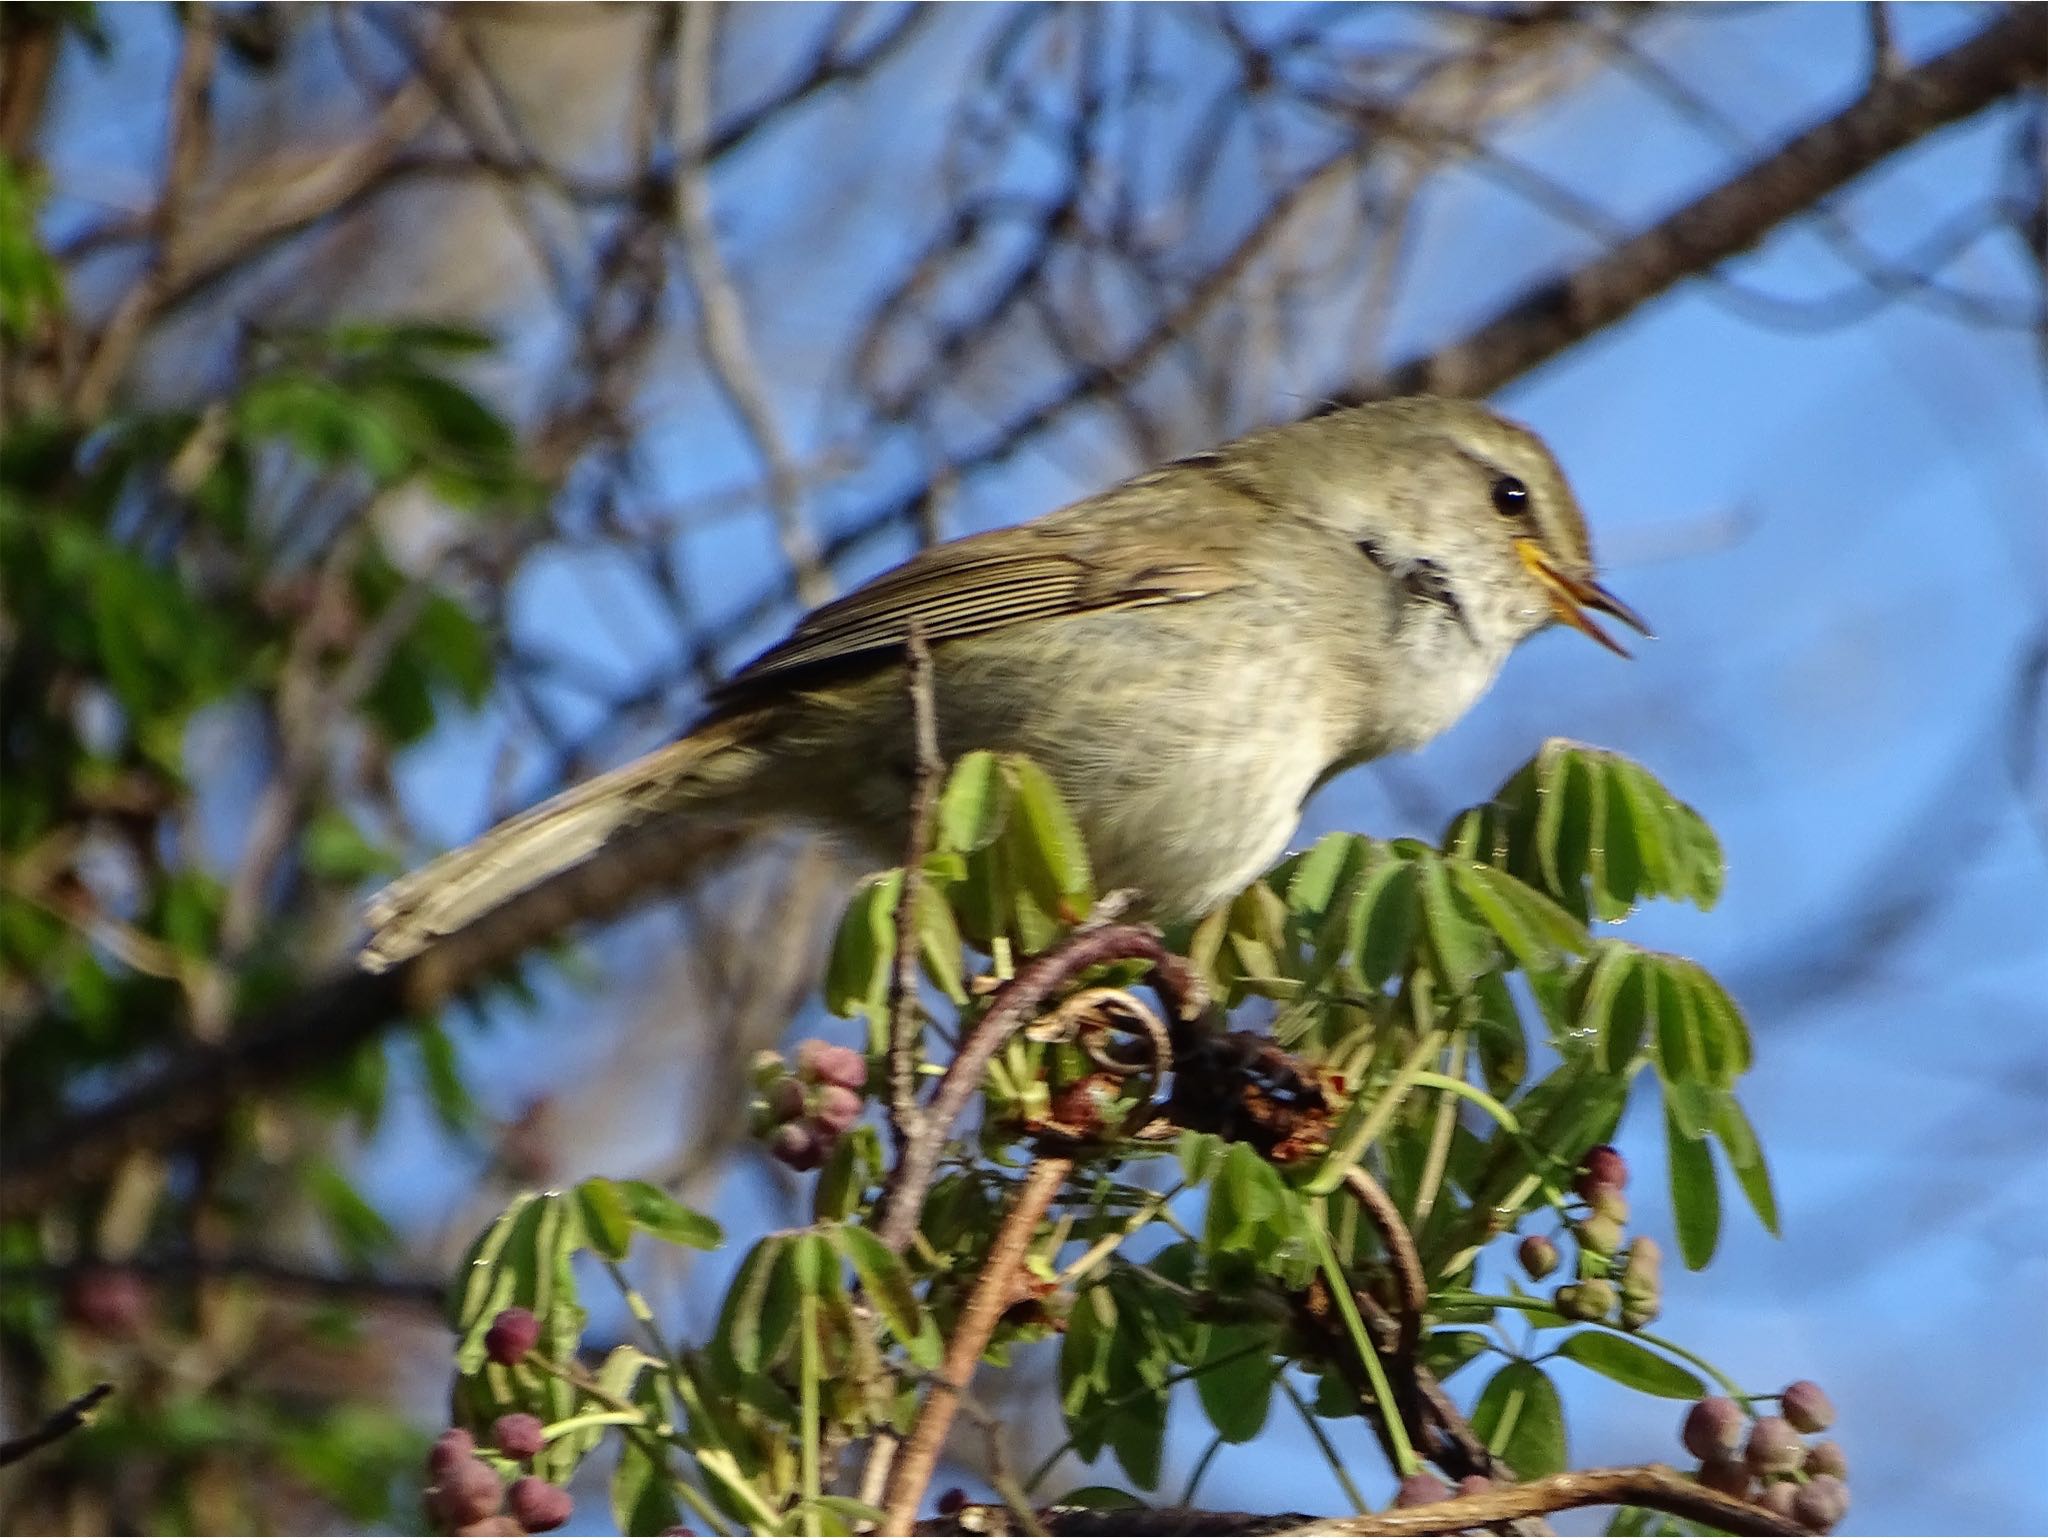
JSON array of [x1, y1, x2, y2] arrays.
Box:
[[362, 397, 1649, 969]]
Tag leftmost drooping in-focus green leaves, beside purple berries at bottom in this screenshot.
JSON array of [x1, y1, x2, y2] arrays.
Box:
[[453, 1171, 921, 1532]]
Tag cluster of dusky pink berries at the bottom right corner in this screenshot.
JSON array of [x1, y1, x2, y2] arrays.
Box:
[[1681, 1378, 1849, 1532]]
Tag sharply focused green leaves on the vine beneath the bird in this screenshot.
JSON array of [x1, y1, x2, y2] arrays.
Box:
[[457, 743, 1774, 1532]]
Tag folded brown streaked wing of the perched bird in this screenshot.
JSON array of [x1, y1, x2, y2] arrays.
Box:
[[719, 522, 1241, 702]]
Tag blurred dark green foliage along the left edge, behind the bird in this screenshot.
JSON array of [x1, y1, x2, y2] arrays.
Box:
[[0, 174, 535, 1532]]
